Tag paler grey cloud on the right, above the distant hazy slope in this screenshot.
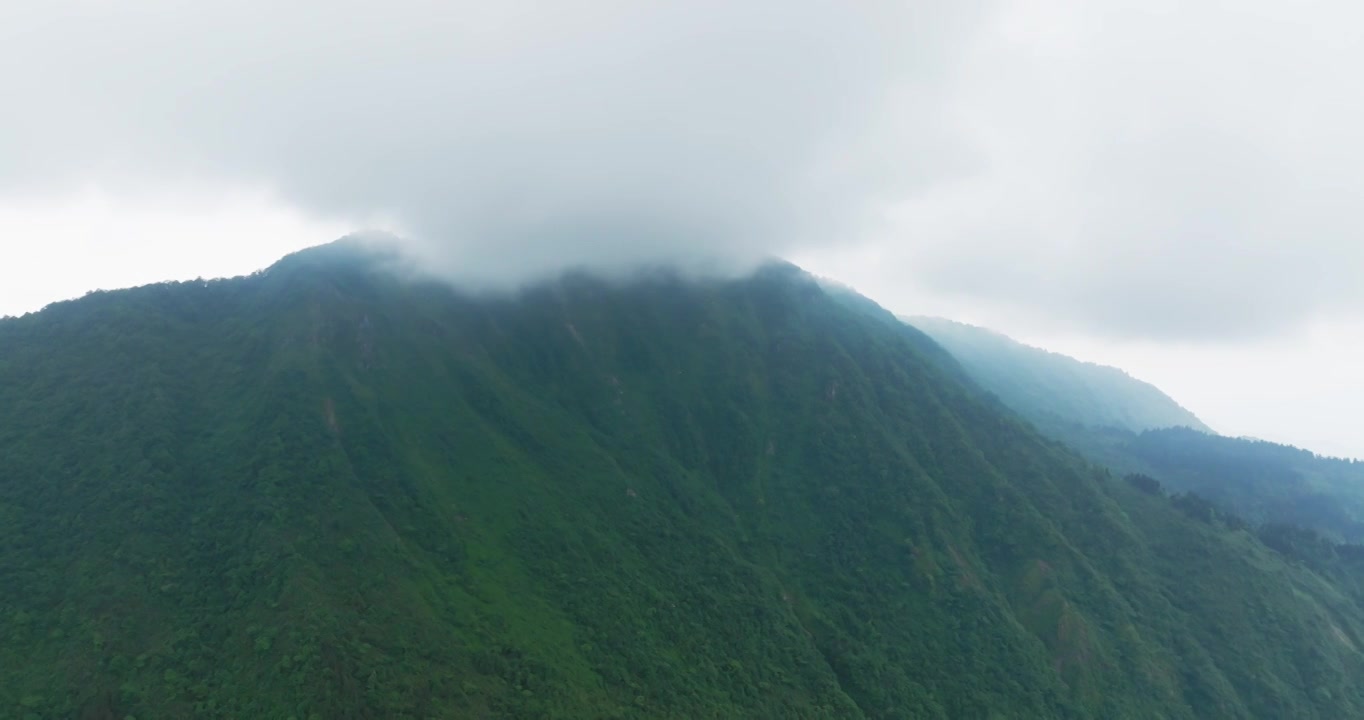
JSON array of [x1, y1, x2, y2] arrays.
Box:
[[856, 0, 1364, 341]]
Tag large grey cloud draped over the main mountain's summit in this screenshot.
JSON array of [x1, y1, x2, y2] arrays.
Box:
[[0, 0, 983, 284]]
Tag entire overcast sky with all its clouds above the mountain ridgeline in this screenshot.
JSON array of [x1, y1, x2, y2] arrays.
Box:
[[0, 0, 1364, 455]]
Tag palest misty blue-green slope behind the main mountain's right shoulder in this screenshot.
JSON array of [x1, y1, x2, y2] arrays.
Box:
[[904, 316, 1211, 432]]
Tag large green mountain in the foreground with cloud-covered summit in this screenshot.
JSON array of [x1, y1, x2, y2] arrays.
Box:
[[0, 243, 1364, 720]]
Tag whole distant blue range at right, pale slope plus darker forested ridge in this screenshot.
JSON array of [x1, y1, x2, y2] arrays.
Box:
[[907, 318, 1364, 543]]
